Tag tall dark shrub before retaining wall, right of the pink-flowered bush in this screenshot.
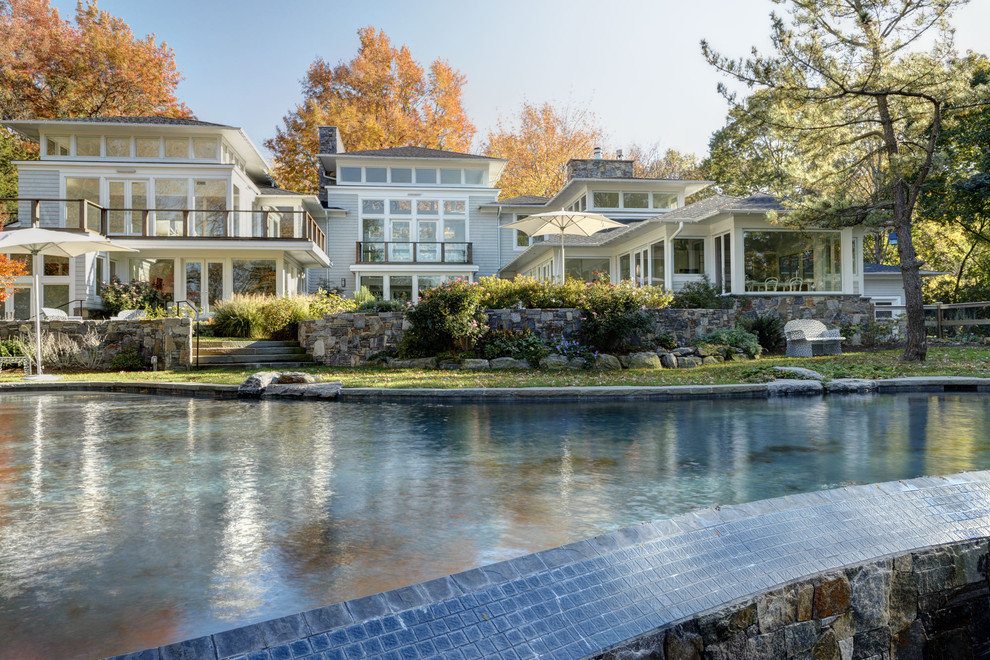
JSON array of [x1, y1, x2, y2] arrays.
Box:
[[581, 281, 653, 353]]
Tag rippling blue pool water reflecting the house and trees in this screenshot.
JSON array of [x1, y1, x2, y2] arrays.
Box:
[[0, 394, 990, 658]]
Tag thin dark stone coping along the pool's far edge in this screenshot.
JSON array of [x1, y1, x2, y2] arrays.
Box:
[[0, 376, 990, 401]]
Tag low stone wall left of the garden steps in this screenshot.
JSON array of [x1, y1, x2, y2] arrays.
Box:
[[0, 318, 193, 369]]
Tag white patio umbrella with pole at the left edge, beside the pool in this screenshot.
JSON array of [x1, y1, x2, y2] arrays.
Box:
[[0, 225, 136, 376]]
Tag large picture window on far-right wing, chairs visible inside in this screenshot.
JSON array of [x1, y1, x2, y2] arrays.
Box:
[[743, 231, 842, 292]]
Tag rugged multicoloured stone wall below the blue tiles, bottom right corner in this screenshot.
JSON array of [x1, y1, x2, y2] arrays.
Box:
[[594, 540, 990, 660]]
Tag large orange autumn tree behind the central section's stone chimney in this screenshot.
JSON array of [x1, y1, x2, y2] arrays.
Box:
[[265, 27, 475, 192]]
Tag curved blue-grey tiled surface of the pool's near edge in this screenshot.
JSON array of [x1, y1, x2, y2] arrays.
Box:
[[102, 471, 990, 660]]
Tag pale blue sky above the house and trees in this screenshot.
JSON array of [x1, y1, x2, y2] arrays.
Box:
[[52, 0, 990, 156]]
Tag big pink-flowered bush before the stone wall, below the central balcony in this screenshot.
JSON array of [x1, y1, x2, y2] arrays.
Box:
[[398, 278, 488, 358]]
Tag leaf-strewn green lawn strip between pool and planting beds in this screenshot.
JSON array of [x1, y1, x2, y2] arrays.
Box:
[[0, 347, 990, 388]]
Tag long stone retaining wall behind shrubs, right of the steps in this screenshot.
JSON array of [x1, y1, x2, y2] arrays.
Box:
[[299, 295, 873, 366]]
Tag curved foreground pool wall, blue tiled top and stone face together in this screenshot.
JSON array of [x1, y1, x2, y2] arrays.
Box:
[[119, 472, 990, 660]]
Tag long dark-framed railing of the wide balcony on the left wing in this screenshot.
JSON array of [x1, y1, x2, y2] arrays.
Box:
[[0, 199, 327, 252]]
